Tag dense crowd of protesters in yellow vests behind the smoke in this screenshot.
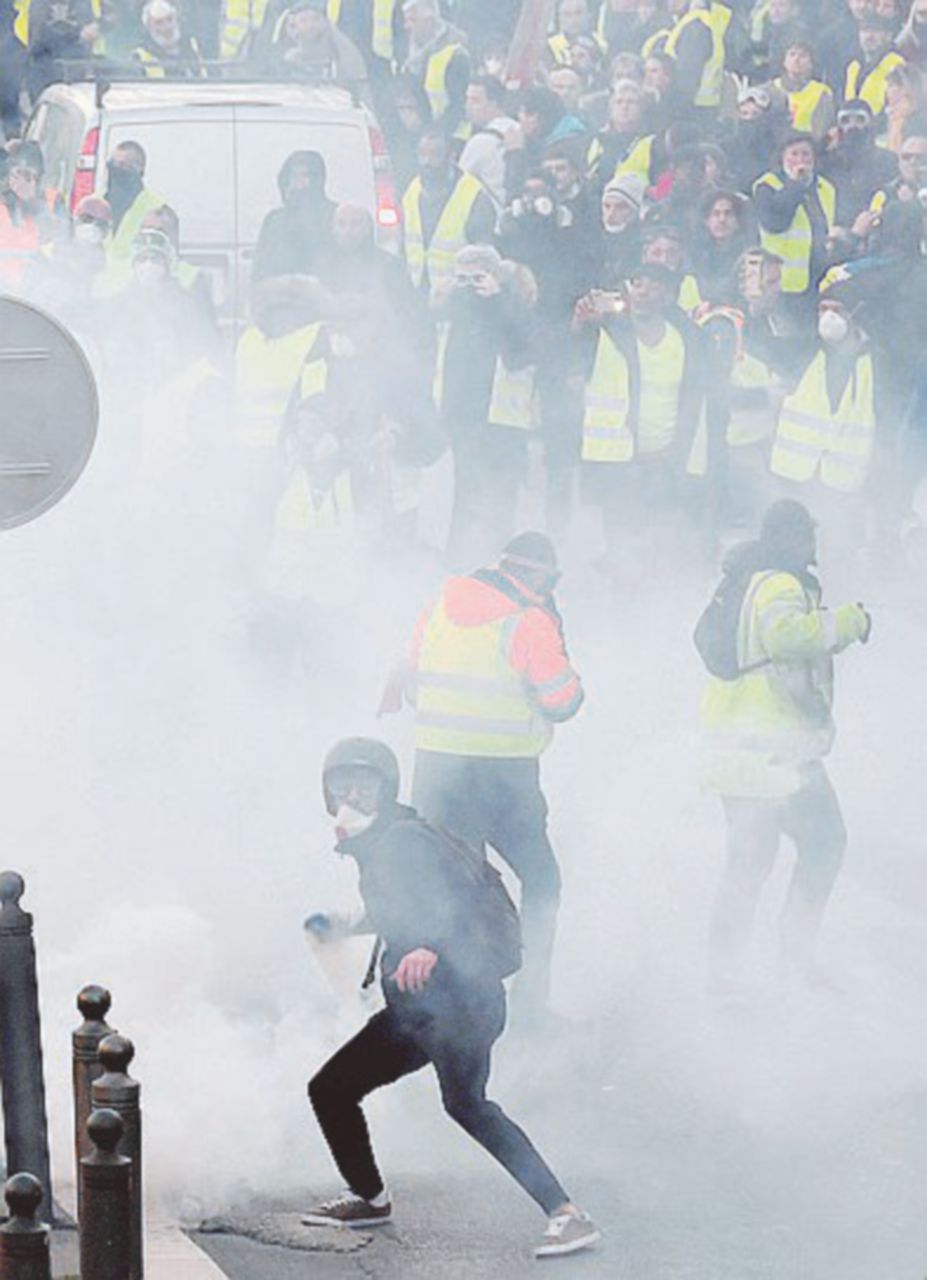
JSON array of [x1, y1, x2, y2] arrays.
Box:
[[0, 0, 927, 593]]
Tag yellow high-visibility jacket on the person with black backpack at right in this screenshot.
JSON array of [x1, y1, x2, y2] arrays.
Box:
[[700, 570, 836, 797]]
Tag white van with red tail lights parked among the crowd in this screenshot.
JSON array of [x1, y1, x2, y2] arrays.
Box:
[[26, 79, 401, 325]]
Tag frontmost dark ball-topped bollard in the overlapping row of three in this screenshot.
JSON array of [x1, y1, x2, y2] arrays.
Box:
[[79, 1110, 132, 1280]]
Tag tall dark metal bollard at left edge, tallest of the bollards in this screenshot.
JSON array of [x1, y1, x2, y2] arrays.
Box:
[[0, 872, 52, 1222]]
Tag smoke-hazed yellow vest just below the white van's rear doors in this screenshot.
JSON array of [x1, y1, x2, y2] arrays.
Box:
[[236, 323, 326, 448]]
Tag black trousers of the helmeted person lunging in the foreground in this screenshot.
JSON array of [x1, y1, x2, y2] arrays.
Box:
[[309, 988, 570, 1215]]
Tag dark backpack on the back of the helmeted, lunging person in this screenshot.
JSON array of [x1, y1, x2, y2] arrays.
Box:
[[431, 827, 522, 979]]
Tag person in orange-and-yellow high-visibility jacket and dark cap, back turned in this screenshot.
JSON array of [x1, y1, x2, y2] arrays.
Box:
[[410, 532, 584, 1024]]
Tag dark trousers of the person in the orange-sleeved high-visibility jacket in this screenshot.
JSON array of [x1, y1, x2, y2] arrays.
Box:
[[412, 751, 561, 1016]]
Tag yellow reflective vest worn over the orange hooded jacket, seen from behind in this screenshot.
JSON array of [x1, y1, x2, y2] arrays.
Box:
[[415, 599, 553, 759]]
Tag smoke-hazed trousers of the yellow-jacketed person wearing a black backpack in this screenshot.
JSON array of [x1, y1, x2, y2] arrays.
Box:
[[711, 764, 846, 975]]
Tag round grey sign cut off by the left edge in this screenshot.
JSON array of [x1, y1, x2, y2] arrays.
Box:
[[0, 297, 99, 529]]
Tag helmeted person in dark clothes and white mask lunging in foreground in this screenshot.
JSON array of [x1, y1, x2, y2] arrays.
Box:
[[303, 739, 599, 1257]]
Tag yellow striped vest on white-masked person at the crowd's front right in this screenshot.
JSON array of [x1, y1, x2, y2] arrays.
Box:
[[770, 351, 876, 493]]
